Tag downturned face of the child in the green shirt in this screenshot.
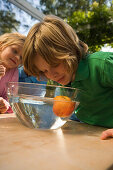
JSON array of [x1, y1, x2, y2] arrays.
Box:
[[34, 56, 72, 85]]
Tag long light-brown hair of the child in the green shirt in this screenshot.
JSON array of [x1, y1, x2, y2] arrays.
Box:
[[22, 15, 88, 77]]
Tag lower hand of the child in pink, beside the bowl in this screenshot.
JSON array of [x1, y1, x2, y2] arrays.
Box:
[[0, 97, 10, 113]]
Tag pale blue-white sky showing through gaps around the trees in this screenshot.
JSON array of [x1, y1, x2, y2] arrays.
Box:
[[0, 0, 113, 52]]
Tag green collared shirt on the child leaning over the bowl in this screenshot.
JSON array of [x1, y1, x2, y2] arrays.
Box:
[[71, 52, 113, 128]]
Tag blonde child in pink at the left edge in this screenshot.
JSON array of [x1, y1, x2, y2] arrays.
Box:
[[0, 33, 25, 113]]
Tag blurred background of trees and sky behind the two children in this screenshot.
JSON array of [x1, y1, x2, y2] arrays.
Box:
[[0, 0, 113, 52]]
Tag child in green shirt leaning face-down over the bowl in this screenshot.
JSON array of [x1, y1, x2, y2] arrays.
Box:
[[23, 16, 113, 139]]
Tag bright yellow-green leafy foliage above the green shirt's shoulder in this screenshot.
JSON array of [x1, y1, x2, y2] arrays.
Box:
[[68, 3, 113, 52]]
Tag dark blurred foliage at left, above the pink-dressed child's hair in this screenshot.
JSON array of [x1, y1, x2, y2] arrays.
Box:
[[0, 10, 20, 35]]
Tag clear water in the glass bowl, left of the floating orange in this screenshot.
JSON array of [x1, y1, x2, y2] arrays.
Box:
[[9, 95, 66, 129]]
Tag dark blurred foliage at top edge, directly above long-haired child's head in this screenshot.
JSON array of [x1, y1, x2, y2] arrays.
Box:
[[40, 0, 91, 18]]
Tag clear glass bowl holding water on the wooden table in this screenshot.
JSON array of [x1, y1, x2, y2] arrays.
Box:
[[7, 82, 77, 129]]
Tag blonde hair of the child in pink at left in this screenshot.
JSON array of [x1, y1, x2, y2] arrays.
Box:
[[0, 32, 26, 51]]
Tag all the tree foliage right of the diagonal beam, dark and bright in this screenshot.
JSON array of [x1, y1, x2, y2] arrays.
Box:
[[40, 0, 113, 52]]
